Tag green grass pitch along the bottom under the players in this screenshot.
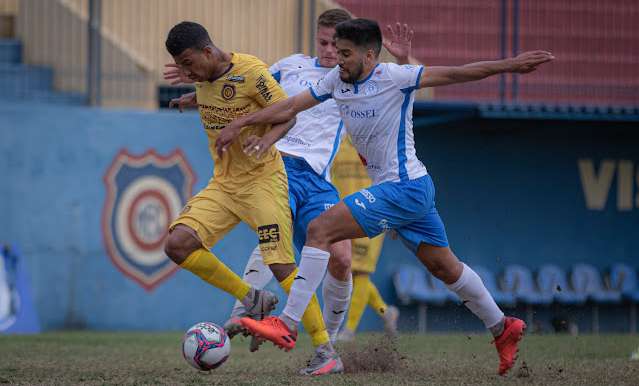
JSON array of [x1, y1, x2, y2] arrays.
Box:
[[0, 332, 639, 385]]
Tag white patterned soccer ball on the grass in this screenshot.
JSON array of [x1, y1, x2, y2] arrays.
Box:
[[182, 322, 231, 371]]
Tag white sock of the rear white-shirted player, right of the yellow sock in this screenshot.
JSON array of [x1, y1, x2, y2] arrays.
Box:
[[322, 272, 353, 342]]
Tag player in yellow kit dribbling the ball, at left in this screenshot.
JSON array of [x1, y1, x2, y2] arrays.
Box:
[[165, 22, 330, 368]]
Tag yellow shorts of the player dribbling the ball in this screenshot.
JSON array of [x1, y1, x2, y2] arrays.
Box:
[[169, 166, 295, 265]]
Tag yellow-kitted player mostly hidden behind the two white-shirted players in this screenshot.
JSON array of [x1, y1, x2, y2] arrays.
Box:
[[331, 137, 399, 341]]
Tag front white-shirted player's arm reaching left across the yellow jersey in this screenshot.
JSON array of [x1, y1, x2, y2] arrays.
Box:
[[215, 90, 320, 157]]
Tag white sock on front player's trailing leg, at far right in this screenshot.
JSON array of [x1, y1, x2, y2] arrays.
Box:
[[447, 263, 504, 329]]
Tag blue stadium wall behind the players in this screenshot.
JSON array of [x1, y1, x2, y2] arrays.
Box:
[[0, 104, 639, 330]]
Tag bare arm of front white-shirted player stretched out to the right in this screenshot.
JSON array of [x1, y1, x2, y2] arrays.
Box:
[[419, 51, 555, 88]]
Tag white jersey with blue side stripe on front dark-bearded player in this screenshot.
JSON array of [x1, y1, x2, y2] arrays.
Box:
[[311, 63, 428, 184]]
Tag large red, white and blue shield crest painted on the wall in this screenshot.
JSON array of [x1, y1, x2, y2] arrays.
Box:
[[102, 149, 195, 291]]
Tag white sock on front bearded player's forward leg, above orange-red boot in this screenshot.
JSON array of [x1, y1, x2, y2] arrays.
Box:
[[282, 246, 331, 323]]
